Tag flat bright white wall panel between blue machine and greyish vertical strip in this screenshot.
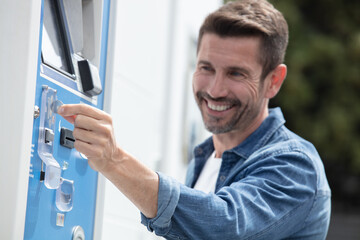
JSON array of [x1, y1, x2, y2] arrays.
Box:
[[102, 0, 169, 239]]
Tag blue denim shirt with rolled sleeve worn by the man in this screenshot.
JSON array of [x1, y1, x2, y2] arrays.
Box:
[[142, 108, 331, 240]]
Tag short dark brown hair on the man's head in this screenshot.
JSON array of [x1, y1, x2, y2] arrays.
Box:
[[197, 0, 289, 79]]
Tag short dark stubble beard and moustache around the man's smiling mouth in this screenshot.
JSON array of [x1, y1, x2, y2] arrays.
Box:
[[196, 92, 246, 134]]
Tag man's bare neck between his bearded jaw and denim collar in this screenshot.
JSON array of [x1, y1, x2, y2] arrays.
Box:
[[213, 107, 269, 158]]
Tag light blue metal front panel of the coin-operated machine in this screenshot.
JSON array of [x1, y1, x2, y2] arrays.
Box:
[[24, 0, 110, 240]]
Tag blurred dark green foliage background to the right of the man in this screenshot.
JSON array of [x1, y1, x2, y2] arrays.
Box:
[[262, 0, 360, 239]]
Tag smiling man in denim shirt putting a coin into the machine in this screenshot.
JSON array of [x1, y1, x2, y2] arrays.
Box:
[[59, 0, 330, 239]]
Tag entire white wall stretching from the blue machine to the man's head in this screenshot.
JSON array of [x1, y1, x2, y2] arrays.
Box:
[[102, 0, 220, 240]]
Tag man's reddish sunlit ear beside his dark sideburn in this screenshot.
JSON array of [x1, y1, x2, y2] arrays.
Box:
[[265, 64, 287, 99]]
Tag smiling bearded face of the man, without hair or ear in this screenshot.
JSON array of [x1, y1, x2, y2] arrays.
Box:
[[193, 33, 267, 134]]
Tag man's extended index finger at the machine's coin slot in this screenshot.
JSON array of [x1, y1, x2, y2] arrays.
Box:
[[58, 104, 103, 120]]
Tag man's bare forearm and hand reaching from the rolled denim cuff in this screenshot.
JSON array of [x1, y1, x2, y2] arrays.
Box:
[[58, 104, 159, 218]]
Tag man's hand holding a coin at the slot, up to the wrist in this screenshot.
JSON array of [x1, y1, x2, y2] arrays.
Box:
[[58, 104, 119, 172]]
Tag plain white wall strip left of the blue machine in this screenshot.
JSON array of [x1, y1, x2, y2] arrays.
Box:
[[0, 0, 41, 240]]
